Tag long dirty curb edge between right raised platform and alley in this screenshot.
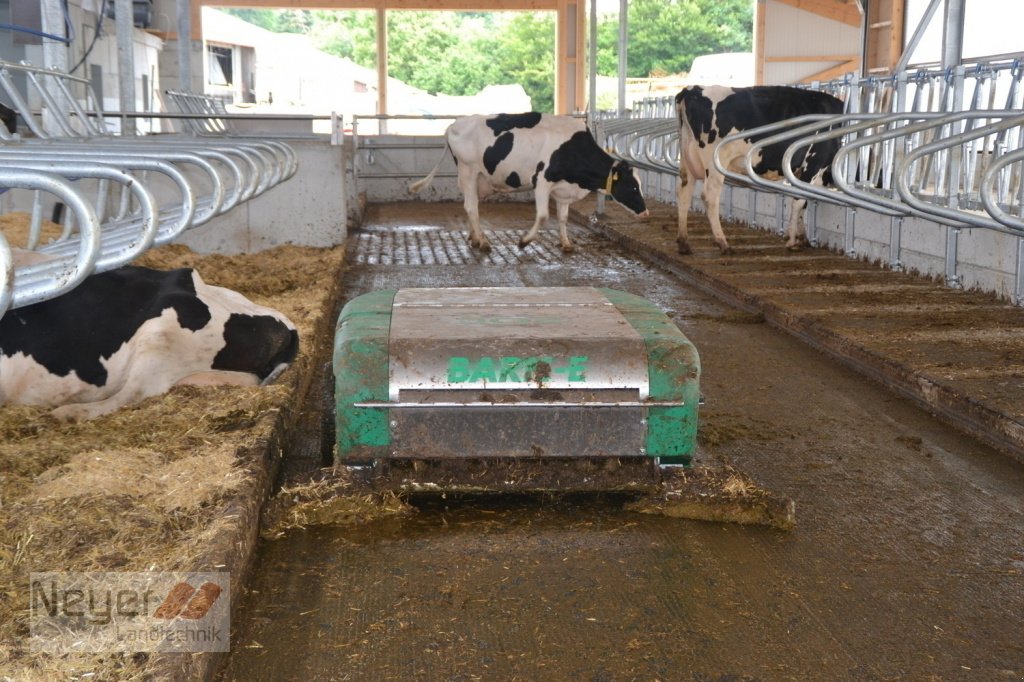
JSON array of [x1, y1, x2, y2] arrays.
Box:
[[570, 209, 1024, 463]]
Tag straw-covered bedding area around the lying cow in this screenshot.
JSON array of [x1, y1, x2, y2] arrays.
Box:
[[0, 214, 343, 680]]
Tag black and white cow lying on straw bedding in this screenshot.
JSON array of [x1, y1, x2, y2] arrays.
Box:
[[0, 266, 299, 419]]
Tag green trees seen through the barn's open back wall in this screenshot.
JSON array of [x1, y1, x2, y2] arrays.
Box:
[[226, 0, 753, 112]]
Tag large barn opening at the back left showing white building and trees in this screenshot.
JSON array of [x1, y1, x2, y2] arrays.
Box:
[[195, 3, 585, 119]]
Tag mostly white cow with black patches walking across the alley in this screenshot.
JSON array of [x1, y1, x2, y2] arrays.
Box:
[[409, 112, 648, 251]]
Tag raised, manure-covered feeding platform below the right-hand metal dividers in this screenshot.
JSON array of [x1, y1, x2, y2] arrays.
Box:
[[573, 197, 1024, 461]]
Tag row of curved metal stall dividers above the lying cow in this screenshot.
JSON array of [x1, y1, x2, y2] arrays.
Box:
[[0, 61, 298, 315]]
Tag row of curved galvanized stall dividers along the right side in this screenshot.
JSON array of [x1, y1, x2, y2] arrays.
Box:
[[595, 59, 1024, 303]]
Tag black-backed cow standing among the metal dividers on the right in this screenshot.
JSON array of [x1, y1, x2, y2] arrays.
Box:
[[676, 85, 843, 254]]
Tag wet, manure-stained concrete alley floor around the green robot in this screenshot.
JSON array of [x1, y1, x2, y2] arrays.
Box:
[[223, 204, 1024, 680]]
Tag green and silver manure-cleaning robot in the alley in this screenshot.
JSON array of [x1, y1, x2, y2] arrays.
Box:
[[334, 287, 792, 525]]
